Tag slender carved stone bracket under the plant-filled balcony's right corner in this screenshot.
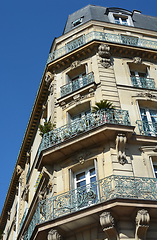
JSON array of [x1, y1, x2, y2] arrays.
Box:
[[116, 133, 127, 165]]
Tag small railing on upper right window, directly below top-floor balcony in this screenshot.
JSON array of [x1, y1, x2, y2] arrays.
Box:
[[131, 76, 155, 89]]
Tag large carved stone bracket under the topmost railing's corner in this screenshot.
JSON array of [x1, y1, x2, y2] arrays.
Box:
[[98, 44, 111, 68]]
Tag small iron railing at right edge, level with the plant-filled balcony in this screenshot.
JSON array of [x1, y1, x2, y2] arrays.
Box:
[[136, 120, 157, 137]]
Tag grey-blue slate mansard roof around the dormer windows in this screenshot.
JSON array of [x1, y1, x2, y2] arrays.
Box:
[[63, 5, 157, 34]]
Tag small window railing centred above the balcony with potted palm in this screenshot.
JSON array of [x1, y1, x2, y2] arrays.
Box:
[[61, 72, 94, 97]]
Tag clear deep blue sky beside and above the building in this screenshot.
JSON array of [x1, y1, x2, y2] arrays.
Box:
[[0, 0, 157, 212]]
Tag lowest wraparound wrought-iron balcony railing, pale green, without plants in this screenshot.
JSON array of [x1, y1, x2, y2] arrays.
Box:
[[24, 175, 157, 240]]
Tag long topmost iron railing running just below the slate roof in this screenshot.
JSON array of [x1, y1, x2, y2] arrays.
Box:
[[47, 31, 157, 64]]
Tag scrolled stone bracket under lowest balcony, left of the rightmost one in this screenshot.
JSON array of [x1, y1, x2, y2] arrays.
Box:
[[100, 212, 119, 240]]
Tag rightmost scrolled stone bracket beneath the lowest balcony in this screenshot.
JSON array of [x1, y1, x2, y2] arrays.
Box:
[[135, 209, 150, 240]]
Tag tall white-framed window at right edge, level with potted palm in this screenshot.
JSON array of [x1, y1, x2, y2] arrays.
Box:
[[140, 108, 157, 136]]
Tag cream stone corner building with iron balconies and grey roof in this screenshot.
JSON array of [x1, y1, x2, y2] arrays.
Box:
[[0, 5, 157, 240]]
